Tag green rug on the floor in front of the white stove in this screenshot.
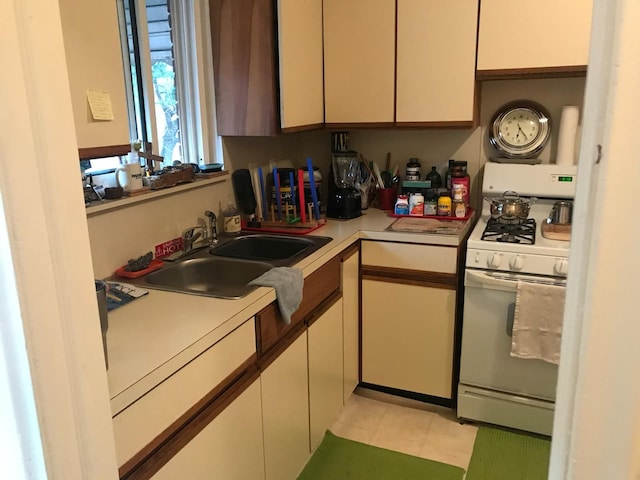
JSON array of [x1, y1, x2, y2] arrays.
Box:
[[465, 427, 551, 480]]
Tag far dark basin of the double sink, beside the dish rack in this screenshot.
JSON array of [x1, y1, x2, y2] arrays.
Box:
[[209, 234, 332, 266]]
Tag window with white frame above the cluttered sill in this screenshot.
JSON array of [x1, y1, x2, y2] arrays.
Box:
[[118, 0, 220, 169]]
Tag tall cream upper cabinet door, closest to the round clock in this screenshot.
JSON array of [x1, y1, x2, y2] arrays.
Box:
[[396, 0, 478, 125]]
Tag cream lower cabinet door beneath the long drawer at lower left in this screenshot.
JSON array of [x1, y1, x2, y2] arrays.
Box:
[[153, 381, 264, 480]]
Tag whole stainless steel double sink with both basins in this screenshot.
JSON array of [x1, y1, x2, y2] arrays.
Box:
[[121, 234, 332, 298]]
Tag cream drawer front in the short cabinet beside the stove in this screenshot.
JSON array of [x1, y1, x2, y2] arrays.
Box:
[[362, 240, 458, 273]]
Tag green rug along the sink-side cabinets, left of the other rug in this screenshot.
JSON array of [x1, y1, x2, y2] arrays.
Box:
[[298, 430, 464, 480]]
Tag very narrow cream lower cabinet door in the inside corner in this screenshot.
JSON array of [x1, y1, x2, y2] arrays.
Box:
[[342, 252, 360, 403]]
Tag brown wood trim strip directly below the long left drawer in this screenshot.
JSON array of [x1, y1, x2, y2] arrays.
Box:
[[119, 355, 260, 480]]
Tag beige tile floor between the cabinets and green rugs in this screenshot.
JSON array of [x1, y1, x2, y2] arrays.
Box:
[[330, 388, 478, 470]]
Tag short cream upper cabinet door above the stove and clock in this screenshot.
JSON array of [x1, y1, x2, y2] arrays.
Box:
[[478, 0, 593, 70]]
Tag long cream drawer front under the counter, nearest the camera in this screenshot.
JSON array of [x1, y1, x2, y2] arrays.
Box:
[[113, 319, 256, 466]]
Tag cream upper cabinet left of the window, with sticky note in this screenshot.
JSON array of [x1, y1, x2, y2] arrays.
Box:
[[60, 0, 130, 152]]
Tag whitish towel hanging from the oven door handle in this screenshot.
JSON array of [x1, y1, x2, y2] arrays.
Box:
[[511, 282, 566, 365]]
